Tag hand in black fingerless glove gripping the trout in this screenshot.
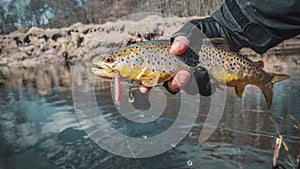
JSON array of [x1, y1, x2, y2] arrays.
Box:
[[139, 17, 220, 96]]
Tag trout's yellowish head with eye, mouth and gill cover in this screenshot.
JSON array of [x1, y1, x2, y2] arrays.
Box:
[[91, 47, 138, 78]]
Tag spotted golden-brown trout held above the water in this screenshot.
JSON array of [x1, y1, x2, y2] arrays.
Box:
[[92, 38, 289, 108]]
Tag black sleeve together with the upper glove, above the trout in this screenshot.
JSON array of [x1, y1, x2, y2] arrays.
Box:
[[171, 0, 300, 54]]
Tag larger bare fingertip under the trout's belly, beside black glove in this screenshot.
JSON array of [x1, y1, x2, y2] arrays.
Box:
[[168, 70, 191, 91]]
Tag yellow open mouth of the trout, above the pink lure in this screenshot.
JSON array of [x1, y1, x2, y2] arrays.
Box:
[[91, 63, 114, 79]]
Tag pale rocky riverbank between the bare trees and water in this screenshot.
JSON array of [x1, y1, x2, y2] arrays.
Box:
[[0, 15, 300, 67]]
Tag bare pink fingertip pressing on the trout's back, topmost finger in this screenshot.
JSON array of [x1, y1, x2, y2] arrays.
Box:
[[170, 36, 190, 55]]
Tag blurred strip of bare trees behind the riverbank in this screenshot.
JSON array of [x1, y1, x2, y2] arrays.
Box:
[[0, 0, 223, 34]]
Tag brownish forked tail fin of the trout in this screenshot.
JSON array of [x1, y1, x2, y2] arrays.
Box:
[[257, 73, 290, 108]]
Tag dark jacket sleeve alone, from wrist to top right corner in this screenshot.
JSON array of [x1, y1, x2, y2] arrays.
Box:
[[212, 0, 300, 53]]
